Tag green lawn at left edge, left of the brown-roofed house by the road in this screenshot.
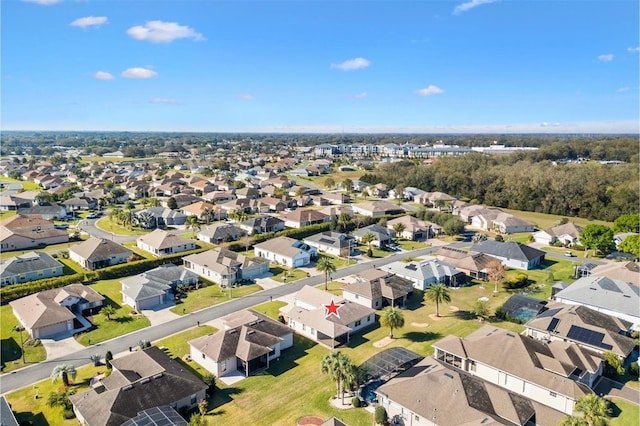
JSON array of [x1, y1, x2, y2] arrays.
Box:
[[0, 305, 47, 373]]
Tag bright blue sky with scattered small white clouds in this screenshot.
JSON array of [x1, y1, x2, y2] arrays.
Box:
[[1, 0, 640, 133]]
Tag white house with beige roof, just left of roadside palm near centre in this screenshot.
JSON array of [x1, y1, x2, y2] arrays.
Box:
[[253, 237, 318, 268]]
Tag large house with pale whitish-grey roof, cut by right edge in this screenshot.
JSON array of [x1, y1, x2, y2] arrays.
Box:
[[554, 276, 640, 330]]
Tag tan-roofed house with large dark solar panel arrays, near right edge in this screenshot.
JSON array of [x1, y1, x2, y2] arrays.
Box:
[[525, 302, 636, 361]]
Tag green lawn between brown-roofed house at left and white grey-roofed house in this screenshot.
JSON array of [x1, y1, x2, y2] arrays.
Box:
[[76, 279, 151, 346]]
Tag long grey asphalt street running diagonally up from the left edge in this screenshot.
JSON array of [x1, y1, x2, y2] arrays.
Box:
[[0, 247, 439, 394]]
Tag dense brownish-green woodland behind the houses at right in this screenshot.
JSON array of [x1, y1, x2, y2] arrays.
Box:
[[361, 154, 640, 221]]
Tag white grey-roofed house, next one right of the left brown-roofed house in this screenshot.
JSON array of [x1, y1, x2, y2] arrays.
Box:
[[120, 263, 199, 311]]
